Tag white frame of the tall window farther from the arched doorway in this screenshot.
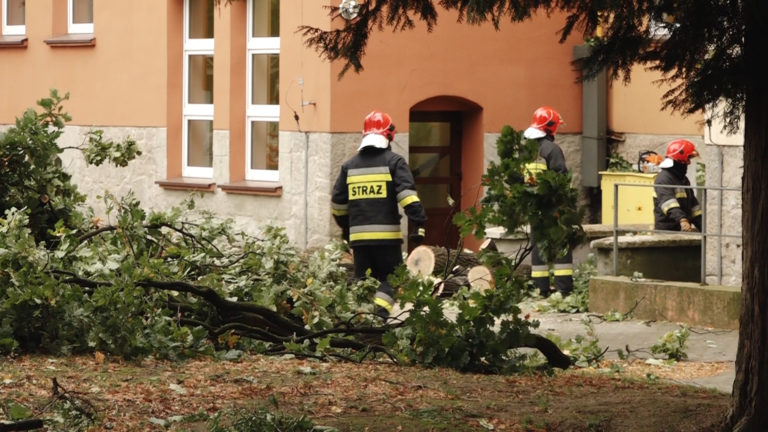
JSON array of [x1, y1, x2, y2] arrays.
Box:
[[181, 0, 214, 178]]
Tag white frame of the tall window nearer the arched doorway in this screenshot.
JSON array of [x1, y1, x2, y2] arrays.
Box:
[[245, 0, 280, 182]]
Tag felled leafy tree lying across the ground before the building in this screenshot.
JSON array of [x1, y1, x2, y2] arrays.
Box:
[[0, 96, 570, 373]]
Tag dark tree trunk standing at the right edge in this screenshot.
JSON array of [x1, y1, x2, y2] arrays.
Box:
[[723, 0, 768, 431]]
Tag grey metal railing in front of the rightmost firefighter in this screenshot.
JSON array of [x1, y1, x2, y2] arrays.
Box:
[[613, 182, 742, 285]]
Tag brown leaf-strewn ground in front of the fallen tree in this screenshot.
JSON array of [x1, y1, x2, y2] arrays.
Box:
[[0, 353, 729, 432]]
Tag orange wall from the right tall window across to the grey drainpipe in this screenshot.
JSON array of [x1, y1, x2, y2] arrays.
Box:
[[280, 8, 581, 133]]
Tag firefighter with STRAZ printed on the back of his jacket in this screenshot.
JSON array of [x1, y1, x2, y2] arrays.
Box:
[[331, 111, 427, 318]]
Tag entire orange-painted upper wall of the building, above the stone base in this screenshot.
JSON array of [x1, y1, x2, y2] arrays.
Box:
[[0, 0, 701, 138]]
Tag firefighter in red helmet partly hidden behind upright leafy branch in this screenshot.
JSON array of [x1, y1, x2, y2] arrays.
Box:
[[523, 106, 573, 297]]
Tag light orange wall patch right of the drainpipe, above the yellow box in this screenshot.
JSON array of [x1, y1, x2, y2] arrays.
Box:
[[607, 65, 704, 135]]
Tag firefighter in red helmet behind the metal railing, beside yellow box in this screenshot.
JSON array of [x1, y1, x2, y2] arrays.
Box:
[[653, 139, 701, 232]]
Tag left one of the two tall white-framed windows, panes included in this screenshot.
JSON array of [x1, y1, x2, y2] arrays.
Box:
[[181, 0, 214, 178]]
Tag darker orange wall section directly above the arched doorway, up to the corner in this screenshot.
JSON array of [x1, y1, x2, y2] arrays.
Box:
[[332, 12, 581, 133]]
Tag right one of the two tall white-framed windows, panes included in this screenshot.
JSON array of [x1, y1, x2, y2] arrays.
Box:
[[245, 0, 280, 181]]
